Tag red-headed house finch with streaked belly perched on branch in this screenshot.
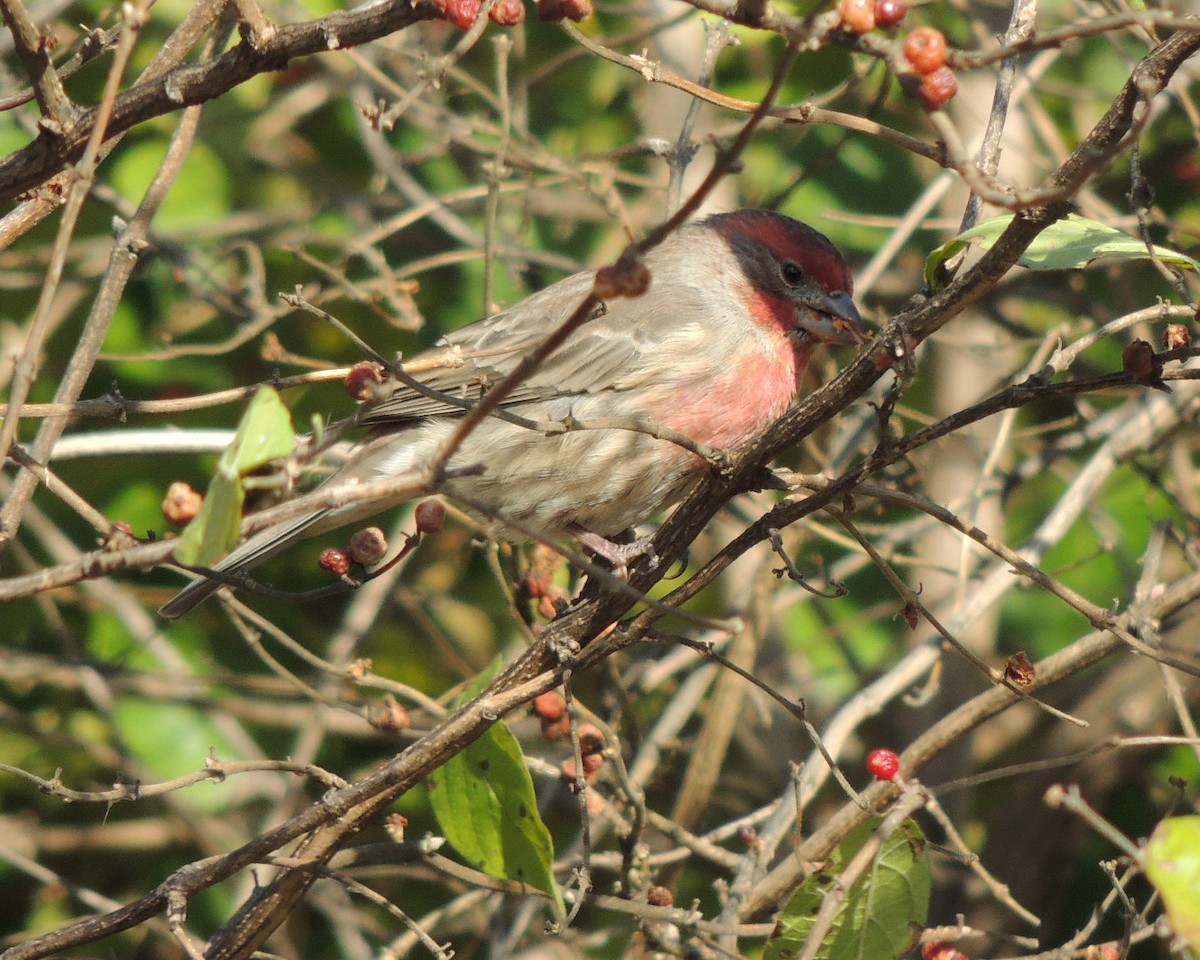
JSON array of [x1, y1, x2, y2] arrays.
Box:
[[161, 210, 863, 618]]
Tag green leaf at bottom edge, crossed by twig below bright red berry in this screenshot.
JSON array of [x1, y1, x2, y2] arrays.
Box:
[[763, 817, 930, 960]]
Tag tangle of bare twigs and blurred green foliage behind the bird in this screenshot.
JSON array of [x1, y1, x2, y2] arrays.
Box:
[[0, 0, 1200, 958]]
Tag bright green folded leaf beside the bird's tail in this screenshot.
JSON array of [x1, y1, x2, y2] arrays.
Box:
[[175, 386, 295, 565]]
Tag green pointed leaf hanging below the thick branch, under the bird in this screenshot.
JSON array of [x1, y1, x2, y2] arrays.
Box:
[[426, 677, 564, 916]]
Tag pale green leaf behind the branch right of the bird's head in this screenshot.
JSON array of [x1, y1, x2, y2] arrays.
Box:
[[925, 214, 1200, 287]]
